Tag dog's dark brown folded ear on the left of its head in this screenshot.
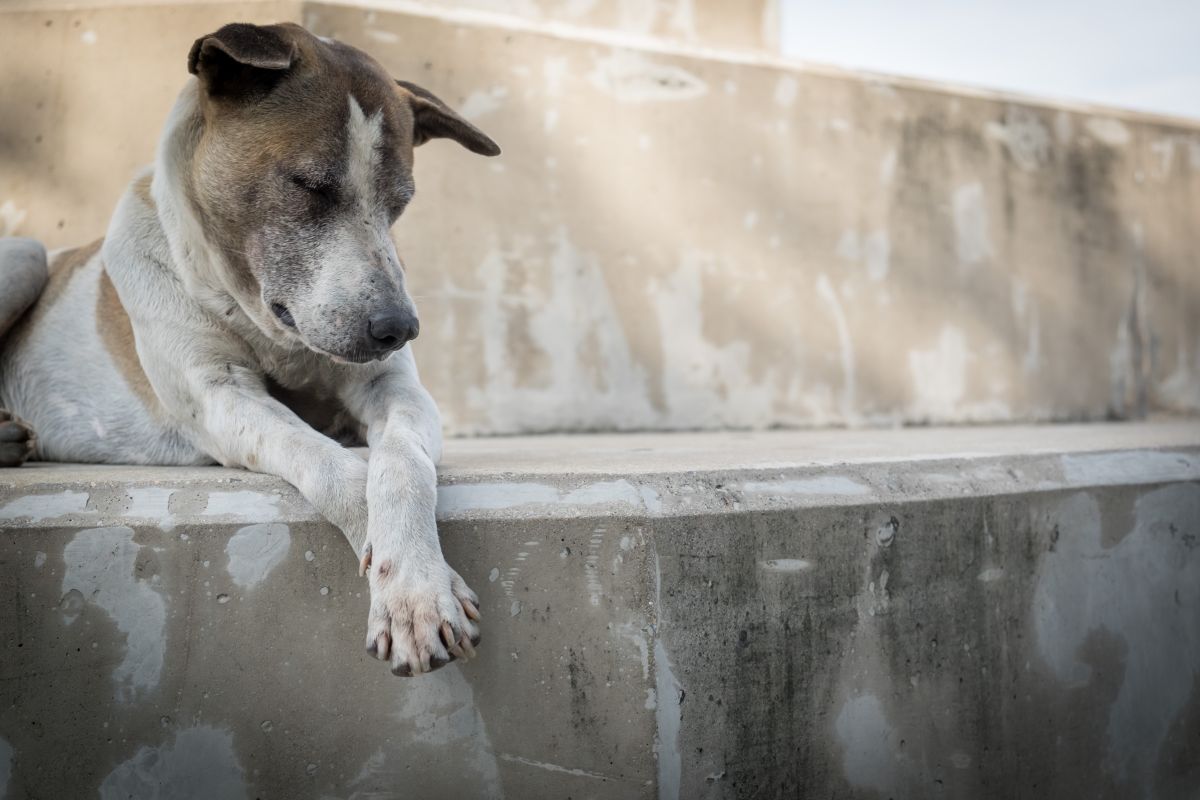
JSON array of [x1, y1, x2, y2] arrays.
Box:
[[187, 23, 295, 96]]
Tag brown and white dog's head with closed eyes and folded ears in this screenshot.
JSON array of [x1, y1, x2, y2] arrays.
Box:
[[187, 24, 500, 362]]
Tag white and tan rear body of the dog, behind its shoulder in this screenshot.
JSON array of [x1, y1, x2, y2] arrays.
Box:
[[0, 221, 205, 467]]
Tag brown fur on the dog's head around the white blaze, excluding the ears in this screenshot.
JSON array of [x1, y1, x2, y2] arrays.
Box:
[[185, 24, 413, 295]]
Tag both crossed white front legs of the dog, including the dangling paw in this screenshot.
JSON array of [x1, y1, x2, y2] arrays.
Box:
[[197, 371, 479, 675]]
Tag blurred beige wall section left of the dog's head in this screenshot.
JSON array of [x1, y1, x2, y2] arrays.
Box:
[[0, 0, 299, 247]]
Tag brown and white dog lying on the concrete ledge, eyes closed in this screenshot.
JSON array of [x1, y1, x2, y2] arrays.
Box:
[[0, 23, 500, 675]]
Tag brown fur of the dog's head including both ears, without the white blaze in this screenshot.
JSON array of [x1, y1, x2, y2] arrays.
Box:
[[188, 23, 500, 278]]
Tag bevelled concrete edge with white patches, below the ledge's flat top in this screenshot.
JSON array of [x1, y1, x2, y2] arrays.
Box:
[[0, 445, 1200, 530]]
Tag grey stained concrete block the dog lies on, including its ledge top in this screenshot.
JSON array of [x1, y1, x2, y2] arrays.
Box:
[[0, 422, 1200, 800]]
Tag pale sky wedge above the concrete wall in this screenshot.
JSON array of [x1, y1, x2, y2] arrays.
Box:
[[780, 0, 1200, 119]]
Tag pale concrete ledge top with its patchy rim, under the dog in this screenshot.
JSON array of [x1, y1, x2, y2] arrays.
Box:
[[0, 420, 1200, 529]]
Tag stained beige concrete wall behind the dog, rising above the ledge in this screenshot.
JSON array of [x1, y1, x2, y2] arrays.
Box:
[[0, 2, 1200, 433]]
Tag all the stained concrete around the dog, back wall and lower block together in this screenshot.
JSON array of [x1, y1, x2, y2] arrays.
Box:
[[0, 0, 1200, 800]]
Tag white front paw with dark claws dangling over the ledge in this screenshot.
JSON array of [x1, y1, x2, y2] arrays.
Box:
[[362, 546, 480, 676]]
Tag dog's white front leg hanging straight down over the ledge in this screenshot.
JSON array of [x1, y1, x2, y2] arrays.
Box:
[[343, 359, 479, 675]]
